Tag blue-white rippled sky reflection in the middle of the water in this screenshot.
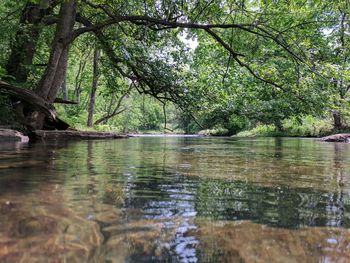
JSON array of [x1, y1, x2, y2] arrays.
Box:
[[124, 168, 199, 263]]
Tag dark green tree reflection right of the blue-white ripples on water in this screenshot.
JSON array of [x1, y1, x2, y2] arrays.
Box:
[[196, 181, 350, 228]]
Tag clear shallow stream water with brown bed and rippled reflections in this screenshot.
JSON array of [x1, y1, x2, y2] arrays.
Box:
[[0, 137, 350, 262]]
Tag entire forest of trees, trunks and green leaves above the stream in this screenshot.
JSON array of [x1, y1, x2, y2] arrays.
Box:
[[0, 0, 350, 135]]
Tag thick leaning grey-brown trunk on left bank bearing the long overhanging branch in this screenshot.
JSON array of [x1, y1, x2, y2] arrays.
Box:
[[26, 0, 76, 129]]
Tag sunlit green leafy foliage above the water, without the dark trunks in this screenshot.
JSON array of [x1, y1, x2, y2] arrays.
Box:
[[0, 0, 350, 136]]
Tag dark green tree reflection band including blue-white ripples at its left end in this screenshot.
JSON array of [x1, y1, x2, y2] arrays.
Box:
[[117, 163, 350, 231]]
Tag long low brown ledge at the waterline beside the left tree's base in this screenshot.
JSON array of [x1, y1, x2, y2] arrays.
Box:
[[29, 130, 129, 141]]
